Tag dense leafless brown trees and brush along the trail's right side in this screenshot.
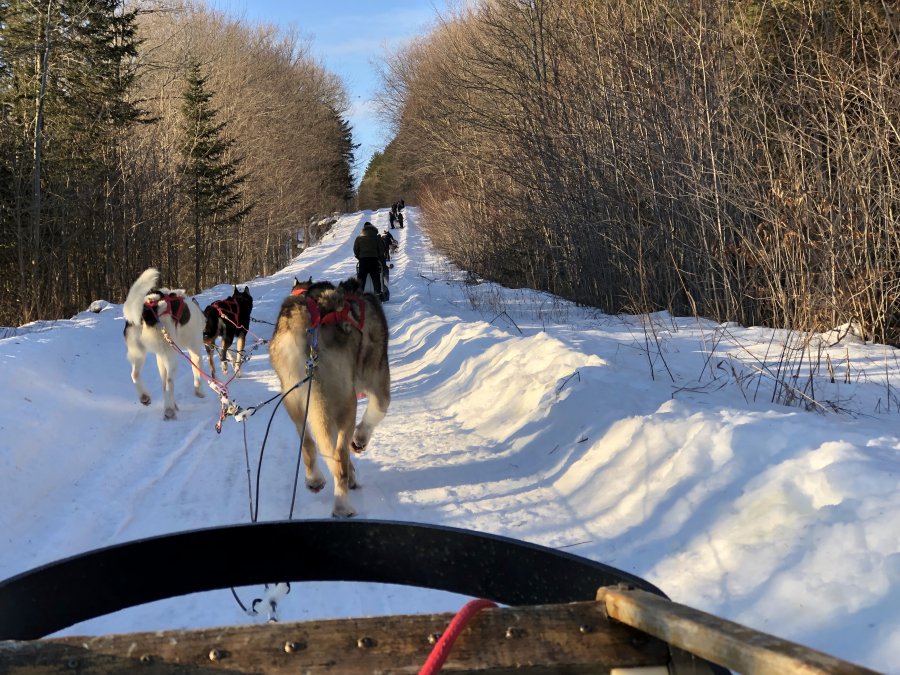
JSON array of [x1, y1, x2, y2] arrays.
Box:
[[360, 0, 900, 344]]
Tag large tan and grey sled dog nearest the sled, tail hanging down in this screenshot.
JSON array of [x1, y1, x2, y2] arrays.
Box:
[[269, 279, 391, 517]]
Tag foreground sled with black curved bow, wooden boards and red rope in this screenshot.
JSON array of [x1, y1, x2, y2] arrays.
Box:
[[0, 520, 874, 675]]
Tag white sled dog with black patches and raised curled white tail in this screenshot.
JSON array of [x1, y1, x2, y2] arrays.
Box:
[[122, 267, 204, 419]]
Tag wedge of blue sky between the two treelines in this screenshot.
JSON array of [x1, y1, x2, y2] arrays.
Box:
[[207, 0, 447, 184]]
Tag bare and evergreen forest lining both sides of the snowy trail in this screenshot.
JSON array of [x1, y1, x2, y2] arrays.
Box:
[[0, 0, 900, 345]]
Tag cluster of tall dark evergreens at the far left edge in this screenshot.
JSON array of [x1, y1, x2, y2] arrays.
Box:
[[0, 0, 140, 321]]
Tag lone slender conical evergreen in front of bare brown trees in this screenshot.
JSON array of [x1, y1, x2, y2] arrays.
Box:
[[180, 61, 251, 291]]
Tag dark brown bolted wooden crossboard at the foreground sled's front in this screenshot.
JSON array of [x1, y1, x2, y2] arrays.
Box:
[[0, 602, 676, 675]]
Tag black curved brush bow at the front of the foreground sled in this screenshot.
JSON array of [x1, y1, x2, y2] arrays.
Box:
[[0, 518, 662, 640]]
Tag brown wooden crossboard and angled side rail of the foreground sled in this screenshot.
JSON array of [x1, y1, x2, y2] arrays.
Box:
[[0, 588, 874, 675]]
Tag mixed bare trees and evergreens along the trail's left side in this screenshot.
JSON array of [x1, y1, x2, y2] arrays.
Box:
[[0, 0, 356, 325]]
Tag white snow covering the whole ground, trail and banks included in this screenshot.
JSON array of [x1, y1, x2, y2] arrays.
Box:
[[0, 207, 900, 673]]
